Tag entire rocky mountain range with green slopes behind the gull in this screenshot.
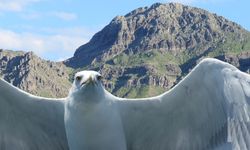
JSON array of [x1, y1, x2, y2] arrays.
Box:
[[0, 3, 250, 97]]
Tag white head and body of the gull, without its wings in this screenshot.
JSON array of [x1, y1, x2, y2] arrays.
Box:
[[65, 71, 126, 150]]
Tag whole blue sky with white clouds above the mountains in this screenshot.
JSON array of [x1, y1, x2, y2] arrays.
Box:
[[0, 0, 250, 61]]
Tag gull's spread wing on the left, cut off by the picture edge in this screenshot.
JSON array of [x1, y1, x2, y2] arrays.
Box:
[[0, 79, 68, 150]]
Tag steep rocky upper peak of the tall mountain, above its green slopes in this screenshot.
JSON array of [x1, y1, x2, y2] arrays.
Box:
[[65, 3, 247, 68]]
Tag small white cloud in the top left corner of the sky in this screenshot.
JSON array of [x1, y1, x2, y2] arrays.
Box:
[[0, 0, 39, 11]]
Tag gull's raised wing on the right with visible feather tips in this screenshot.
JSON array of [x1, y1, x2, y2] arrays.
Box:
[[114, 59, 250, 150]]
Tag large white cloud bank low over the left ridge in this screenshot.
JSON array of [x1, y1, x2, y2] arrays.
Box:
[[0, 29, 89, 60]]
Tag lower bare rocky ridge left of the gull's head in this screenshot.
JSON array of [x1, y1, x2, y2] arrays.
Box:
[[0, 50, 71, 97]]
